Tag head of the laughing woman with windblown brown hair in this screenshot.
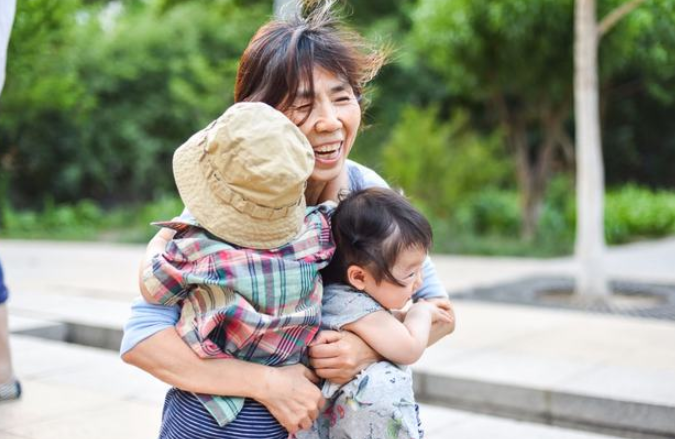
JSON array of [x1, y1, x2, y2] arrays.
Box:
[[234, 8, 386, 199]]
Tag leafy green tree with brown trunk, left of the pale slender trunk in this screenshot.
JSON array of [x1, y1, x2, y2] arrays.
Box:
[[413, 0, 572, 239]]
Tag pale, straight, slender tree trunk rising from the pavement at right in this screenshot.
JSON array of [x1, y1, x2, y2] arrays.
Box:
[[574, 0, 609, 298]]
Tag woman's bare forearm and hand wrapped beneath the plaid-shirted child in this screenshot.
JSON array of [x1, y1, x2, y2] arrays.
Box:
[[122, 328, 324, 433]]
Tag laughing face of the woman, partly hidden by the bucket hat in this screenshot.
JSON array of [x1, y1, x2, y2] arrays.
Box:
[[286, 68, 361, 182]]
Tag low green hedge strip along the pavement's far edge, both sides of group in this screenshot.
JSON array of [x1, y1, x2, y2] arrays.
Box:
[[0, 186, 675, 256]]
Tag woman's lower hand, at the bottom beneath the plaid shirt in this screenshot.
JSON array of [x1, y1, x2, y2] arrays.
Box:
[[254, 364, 325, 434]]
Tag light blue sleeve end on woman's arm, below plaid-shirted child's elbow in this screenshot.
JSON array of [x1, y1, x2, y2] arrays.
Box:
[[120, 297, 180, 355]]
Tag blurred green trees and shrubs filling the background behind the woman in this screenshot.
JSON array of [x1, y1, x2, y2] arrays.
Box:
[[0, 0, 675, 256]]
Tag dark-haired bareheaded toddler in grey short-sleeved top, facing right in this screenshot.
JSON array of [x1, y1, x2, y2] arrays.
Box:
[[297, 188, 452, 439]]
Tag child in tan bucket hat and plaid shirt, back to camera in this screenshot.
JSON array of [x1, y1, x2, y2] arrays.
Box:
[[142, 103, 335, 437]]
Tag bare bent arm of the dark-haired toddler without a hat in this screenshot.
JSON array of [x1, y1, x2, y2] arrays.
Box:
[[343, 301, 444, 365]]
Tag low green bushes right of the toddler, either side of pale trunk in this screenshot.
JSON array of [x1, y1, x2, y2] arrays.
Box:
[[431, 183, 675, 256]]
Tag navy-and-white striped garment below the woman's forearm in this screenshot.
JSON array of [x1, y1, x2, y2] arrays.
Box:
[[159, 388, 288, 439]]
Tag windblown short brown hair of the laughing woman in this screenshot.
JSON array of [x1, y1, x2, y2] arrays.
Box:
[[234, 0, 386, 116]]
